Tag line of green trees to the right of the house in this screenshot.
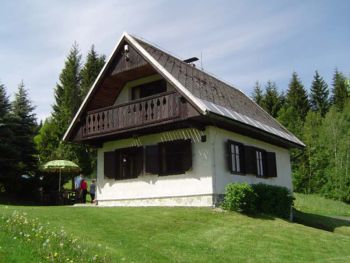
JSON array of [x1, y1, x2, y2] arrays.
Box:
[[252, 70, 350, 202]]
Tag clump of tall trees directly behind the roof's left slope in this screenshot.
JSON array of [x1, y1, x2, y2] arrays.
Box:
[[36, 44, 105, 175]]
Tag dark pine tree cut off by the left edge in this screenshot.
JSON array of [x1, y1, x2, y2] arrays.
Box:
[[0, 84, 18, 186]]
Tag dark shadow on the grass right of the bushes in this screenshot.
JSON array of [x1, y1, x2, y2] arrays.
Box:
[[294, 210, 350, 232]]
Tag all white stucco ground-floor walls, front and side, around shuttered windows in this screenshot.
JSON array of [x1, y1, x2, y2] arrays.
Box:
[[97, 126, 292, 206]]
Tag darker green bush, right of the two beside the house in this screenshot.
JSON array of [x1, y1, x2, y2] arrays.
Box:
[[252, 183, 294, 218]]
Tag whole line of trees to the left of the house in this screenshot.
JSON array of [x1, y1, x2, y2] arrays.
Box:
[[0, 44, 105, 195]]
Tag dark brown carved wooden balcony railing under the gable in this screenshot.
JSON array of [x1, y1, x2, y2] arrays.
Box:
[[81, 91, 187, 139]]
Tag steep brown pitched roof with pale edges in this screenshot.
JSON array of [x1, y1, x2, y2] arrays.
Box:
[[63, 33, 304, 146]]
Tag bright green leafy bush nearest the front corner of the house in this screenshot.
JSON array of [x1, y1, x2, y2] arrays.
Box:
[[222, 183, 257, 214]]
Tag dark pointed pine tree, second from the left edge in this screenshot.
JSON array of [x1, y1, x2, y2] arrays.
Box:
[[12, 82, 37, 175]]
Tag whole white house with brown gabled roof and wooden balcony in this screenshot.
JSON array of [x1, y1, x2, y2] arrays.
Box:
[[63, 33, 304, 206]]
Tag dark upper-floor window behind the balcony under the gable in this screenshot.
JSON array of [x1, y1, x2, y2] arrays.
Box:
[[131, 79, 166, 100]]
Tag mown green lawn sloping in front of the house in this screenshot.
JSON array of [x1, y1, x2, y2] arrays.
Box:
[[0, 195, 350, 262]]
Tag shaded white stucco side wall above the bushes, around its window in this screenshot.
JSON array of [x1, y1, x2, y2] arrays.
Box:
[[207, 126, 292, 194]]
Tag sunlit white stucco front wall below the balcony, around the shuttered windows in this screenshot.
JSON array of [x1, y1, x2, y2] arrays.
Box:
[[97, 129, 214, 206]]
